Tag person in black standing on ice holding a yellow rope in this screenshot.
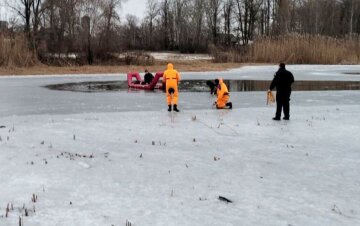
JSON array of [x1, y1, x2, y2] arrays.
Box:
[[269, 63, 294, 120]]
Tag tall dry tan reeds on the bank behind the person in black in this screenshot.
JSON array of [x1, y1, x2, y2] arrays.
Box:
[[248, 34, 360, 64]]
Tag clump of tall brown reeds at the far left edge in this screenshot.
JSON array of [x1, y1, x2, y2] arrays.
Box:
[[0, 35, 37, 68]]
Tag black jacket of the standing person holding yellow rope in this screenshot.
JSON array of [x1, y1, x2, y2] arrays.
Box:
[[270, 68, 294, 95]]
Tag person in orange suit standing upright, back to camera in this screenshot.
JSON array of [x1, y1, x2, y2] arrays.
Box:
[[163, 63, 180, 112]]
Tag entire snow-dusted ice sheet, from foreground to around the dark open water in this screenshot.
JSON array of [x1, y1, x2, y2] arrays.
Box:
[[0, 66, 360, 226]]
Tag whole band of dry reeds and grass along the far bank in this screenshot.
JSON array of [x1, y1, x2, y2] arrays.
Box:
[[0, 34, 360, 75]]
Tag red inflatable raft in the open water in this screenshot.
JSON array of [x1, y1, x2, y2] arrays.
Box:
[[127, 72, 163, 90]]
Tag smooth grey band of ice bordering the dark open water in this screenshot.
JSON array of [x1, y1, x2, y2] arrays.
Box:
[[0, 65, 360, 117]]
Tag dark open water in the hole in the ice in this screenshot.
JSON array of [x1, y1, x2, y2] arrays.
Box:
[[46, 80, 360, 92]]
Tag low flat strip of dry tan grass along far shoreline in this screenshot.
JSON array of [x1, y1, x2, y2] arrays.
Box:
[[0, 61, 242, 75]]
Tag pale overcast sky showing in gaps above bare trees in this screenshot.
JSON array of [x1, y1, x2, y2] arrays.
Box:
[[0, 0, 146, 20]]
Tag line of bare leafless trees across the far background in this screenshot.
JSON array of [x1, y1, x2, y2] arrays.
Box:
[[2, 0, 360, 64]]
